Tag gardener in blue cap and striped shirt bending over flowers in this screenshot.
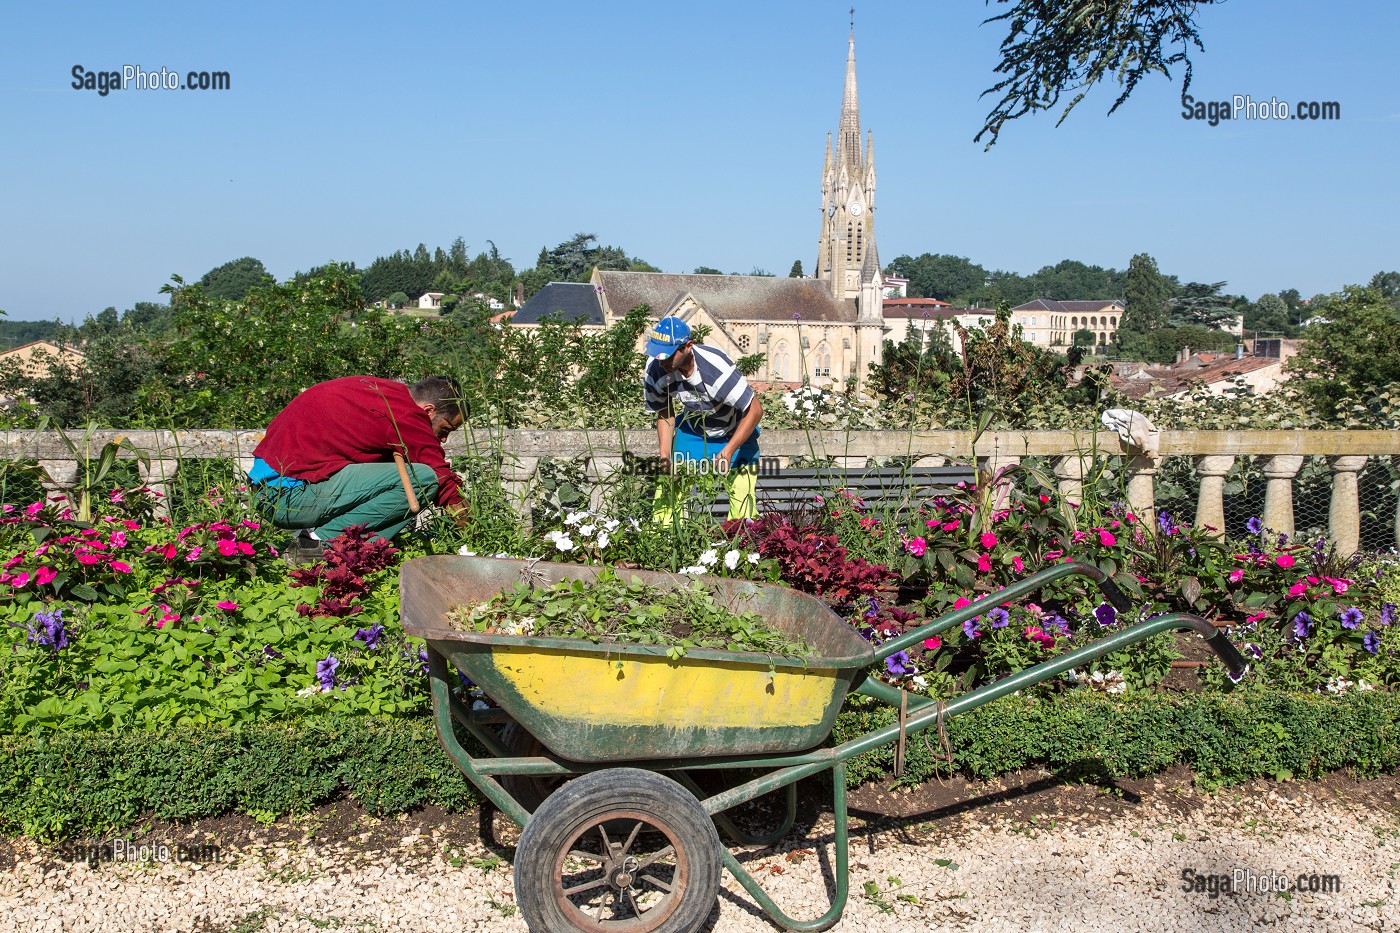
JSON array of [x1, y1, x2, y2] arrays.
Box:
[[643, 318, 763, 521]]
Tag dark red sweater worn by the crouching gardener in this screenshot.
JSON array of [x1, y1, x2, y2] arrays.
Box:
[[253, 375, 462, 506]]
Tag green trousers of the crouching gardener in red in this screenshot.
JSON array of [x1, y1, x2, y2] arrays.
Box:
[[253, 462, 438, 541]]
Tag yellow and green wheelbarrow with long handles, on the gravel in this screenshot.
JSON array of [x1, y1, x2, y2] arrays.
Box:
[[399, 555, 1246, 933]]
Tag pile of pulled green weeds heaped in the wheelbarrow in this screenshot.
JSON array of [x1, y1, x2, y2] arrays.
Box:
[[436, 567, 812, 658]]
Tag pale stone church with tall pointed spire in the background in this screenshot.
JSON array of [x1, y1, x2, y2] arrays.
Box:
[[512, 29, 885, 385]]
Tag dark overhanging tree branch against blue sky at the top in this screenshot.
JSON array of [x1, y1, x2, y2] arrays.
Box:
[[973, 0, 1218, 148]]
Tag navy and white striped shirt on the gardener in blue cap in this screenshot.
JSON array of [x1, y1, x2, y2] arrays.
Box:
[[641, 343, 753, 440]]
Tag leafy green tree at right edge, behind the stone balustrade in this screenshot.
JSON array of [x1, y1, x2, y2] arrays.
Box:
[[1280, 286, 1400, 427]]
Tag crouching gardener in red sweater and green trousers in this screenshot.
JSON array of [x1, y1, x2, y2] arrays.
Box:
[[248, 375, 466, 553]]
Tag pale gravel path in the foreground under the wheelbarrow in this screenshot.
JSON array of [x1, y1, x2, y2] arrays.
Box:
[[0, 779, 1400, 933]]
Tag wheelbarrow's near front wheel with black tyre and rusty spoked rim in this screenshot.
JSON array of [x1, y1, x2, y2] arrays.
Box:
[[515, 768, 720, 933]]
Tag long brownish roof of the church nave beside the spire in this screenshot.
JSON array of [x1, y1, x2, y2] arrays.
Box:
[[593, 270, 855, 324]]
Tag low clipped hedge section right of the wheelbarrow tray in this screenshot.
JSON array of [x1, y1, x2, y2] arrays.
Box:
[[832, 685, 1400, 786]]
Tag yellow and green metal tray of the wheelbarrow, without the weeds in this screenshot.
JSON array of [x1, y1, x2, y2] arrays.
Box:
[[399, 556, 875, 762]]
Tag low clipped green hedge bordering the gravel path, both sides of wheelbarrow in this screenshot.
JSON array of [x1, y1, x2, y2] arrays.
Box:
[[0, 689, 1400, 841]]
